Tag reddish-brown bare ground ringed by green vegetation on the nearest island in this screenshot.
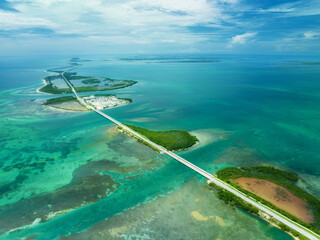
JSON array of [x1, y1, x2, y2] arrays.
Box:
[[230, 177, 313, 223]]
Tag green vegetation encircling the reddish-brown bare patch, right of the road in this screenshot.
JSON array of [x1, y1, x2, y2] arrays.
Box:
[[217, 166, 320, 233]]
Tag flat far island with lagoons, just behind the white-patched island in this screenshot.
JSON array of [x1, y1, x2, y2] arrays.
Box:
[[38, 70, 137, 94]]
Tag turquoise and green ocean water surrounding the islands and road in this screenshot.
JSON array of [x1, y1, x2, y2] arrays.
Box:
[[0, 55, 320, 240]]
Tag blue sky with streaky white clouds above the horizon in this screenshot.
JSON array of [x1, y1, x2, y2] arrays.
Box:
[[0, 0, 320, 56]]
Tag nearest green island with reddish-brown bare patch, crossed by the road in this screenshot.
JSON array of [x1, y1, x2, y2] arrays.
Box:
[[210, 166, 320, 239]]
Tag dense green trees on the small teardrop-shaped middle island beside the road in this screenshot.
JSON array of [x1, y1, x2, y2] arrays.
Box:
[[125, 124, 198, 151]]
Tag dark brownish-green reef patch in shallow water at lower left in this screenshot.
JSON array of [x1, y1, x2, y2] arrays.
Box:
[[0, 160, 120, 234]]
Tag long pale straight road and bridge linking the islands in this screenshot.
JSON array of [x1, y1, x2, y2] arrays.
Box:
[[61, 70, 320, 240]]
